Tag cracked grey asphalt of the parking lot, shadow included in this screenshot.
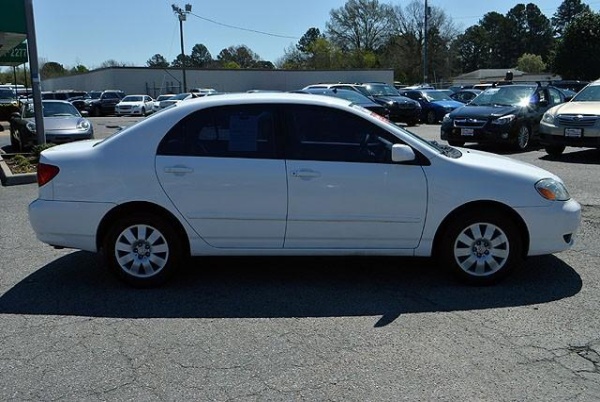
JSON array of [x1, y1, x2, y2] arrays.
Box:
[[0, 117, 600, 401]]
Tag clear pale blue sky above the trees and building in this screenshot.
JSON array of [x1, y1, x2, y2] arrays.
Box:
[[31, 0, 600, 69]]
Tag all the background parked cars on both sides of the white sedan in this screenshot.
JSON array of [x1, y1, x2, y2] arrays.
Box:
[[11, 81, 600, 156]]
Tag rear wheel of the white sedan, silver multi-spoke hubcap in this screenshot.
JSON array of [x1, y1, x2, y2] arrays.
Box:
[[104, 213, 182, 288]]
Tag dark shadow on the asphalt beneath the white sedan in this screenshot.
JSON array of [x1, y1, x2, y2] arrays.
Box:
[[0, 251, 582, 327]]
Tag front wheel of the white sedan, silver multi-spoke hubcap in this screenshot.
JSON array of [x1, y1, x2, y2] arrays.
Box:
[[439, 209, 522, 285]]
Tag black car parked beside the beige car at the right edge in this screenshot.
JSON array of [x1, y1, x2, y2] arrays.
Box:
[[441, 84, 565, 150]]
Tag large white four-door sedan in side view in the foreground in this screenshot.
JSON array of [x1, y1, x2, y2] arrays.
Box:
[[29, 93, 581, 286]]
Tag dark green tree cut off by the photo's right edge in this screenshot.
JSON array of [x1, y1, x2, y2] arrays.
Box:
[[552, 12, 600, 80]]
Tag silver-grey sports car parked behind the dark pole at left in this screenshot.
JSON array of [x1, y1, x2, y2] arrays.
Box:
[[10, 99, 94, 151]]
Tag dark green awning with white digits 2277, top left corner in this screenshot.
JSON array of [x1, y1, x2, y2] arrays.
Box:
[[0, 0, 27, 56]]
